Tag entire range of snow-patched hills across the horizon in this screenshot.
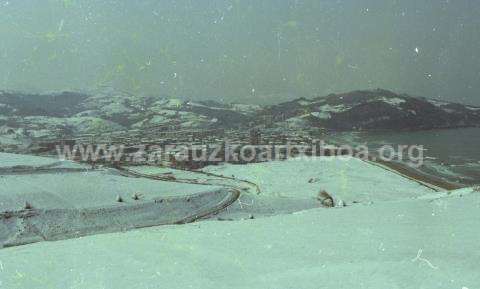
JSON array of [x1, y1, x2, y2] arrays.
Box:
[[0, 88, 480, 145]]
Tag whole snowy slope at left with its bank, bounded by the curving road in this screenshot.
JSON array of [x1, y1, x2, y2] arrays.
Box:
[[0, 153, 232, 246]]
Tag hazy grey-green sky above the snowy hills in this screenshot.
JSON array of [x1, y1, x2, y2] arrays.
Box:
[[0, 0, 480, 105]]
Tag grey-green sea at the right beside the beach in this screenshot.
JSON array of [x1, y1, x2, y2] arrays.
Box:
[[327, 128, 480, 186]]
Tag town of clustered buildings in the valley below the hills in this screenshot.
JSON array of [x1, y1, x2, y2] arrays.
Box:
[[16, 126, 339, 170]]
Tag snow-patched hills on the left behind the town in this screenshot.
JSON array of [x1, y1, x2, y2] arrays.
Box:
[[0, 88, 261, 143]]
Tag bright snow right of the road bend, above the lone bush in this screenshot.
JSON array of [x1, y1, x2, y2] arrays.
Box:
[[204, 157, 432, 204]]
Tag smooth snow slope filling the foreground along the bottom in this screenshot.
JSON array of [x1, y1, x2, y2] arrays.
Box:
[[0, 187, 480, 289]]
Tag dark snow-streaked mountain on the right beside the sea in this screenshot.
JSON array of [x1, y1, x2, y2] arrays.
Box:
[[261, 89, 480, 130]]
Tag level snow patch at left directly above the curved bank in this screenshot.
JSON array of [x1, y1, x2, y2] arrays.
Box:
[[0, 170, 221, 211]]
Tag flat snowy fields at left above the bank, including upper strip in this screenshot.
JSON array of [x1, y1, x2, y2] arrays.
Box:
[[0, 153, 223, 211]]
